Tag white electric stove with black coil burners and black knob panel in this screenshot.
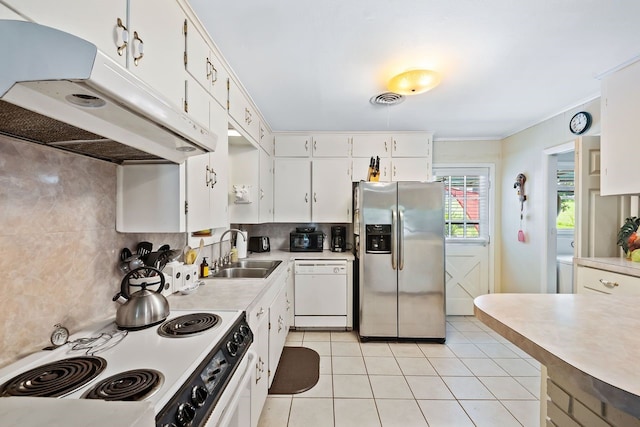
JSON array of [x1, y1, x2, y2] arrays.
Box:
[[0, 310, 253, 426]]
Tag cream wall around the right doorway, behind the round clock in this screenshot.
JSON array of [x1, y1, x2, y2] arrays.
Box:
[[500, 99, 600, 293]]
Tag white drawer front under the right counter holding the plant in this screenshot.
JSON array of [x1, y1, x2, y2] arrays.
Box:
[[576, 265, 640, 295]]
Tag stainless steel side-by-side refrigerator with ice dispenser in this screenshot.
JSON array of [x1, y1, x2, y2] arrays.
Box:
[[354, 181, 446, 342]]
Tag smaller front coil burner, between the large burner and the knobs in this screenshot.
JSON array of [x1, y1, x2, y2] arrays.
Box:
[[82, 369, 164, 401]]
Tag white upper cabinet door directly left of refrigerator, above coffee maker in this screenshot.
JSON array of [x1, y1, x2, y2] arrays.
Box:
[[311, 159, 351, 222]]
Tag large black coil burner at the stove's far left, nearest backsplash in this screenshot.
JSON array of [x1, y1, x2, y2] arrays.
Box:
[[0, 356, 107, 397]]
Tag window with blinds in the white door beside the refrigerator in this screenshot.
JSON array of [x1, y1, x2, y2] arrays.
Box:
[[434, 168, 489, 243]]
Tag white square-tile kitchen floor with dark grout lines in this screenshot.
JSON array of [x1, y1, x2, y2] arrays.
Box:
[[259, 316, 540, 427]]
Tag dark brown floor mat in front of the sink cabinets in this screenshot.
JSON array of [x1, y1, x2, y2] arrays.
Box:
[[269, 347, 320, 394]]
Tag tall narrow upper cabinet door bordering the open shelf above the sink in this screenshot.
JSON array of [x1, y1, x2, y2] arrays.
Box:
[[206, 102, 229, 229]]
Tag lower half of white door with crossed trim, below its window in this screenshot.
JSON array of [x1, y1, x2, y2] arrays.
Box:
[[445, 243, 489, 316]]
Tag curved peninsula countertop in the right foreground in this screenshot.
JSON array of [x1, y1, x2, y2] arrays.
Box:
[[474, 294, 640, 418]]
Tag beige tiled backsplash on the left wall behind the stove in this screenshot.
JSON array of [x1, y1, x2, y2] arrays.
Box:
[[0, 136, 185, 366]]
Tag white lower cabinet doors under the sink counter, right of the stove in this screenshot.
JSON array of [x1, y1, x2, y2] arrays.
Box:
[[248, 265, 290, 427]]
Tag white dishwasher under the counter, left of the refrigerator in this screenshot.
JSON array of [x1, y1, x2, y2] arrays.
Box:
[[294, 260, 347, 328]]
